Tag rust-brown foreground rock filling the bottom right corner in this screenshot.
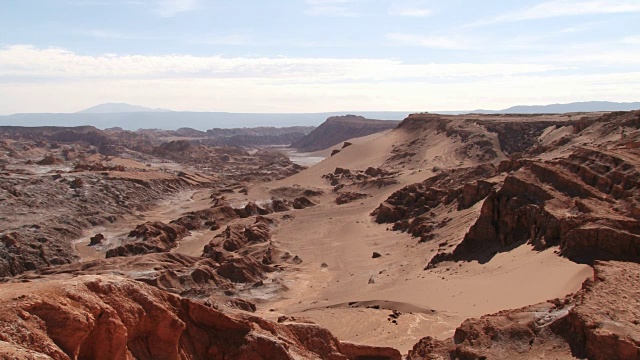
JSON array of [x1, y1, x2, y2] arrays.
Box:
[[408, 262, 640, 360]]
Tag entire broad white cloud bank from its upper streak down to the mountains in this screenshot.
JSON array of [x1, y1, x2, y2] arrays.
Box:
[[0, 45, 640, 114]]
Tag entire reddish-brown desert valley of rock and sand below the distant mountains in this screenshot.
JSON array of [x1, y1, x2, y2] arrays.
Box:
[[0, 111, 640, 360]]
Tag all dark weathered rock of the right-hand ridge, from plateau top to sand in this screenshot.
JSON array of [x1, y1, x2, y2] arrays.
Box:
[[370, 112, 640, 268]]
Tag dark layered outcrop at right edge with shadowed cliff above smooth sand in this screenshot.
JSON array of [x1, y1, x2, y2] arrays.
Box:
[[431, 145, 640, 265]]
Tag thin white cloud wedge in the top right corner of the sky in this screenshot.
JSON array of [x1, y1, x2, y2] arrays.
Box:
[[471, 0, 640, 26]]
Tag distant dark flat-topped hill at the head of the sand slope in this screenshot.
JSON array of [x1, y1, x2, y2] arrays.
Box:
[[291, 115, 400, 151]]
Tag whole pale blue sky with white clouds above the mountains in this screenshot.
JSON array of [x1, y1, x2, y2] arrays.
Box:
[[0, 0, 640, 114]]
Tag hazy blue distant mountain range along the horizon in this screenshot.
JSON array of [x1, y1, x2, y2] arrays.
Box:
[[0, 101, 640, 130]]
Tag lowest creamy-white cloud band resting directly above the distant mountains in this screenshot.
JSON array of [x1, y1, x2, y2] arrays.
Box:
[[0, 72, 640, 114]]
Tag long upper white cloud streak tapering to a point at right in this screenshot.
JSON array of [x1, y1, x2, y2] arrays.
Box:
[[0, 45, 558, 82]]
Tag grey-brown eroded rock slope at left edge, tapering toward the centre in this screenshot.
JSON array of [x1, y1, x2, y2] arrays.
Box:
[[0, 171, 213, 277]]
